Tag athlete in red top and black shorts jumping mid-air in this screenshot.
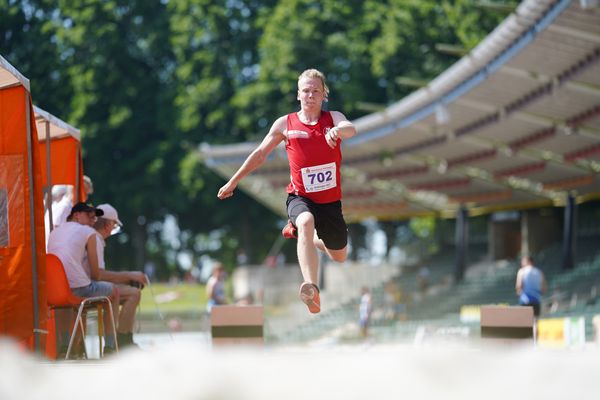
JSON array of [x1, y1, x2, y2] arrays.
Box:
[[217, 69, 356, 314]]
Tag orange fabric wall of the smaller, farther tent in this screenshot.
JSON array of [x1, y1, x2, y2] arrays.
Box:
[[38, 132, 86, 202]]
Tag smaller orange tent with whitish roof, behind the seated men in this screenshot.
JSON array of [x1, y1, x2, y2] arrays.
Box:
[[33, 106, 86, 228]]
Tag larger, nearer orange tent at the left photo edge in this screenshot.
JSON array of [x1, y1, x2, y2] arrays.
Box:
[[0, 56, 47, 350]]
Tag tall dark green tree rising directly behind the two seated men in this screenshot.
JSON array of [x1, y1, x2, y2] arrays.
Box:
[[54, 0, 183, 268]]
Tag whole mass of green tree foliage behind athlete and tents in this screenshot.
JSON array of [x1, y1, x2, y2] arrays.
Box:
[[0, 0, 504, 271]]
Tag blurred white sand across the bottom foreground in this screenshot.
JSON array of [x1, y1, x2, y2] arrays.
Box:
[[0, 341, 600, 400]]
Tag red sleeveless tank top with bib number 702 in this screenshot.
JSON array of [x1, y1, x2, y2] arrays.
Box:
[[285, 111, 342, 203]]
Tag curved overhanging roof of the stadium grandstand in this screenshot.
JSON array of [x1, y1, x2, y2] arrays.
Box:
[[201, 0, 600, 220]]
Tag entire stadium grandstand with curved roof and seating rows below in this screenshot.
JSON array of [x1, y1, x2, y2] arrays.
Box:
[[200, 0, 600, 346]]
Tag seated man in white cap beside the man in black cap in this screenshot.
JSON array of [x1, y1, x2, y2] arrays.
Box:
[[94, 204, 147, 347]]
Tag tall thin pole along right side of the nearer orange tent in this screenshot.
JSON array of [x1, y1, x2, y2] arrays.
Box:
[[25, 91, 40, 352]]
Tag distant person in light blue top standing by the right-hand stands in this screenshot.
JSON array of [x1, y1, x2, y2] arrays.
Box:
[[515, 256, 547, 317]]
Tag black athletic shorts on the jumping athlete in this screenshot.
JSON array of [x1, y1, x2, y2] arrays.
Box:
[[286, 194, 348, 250]]
